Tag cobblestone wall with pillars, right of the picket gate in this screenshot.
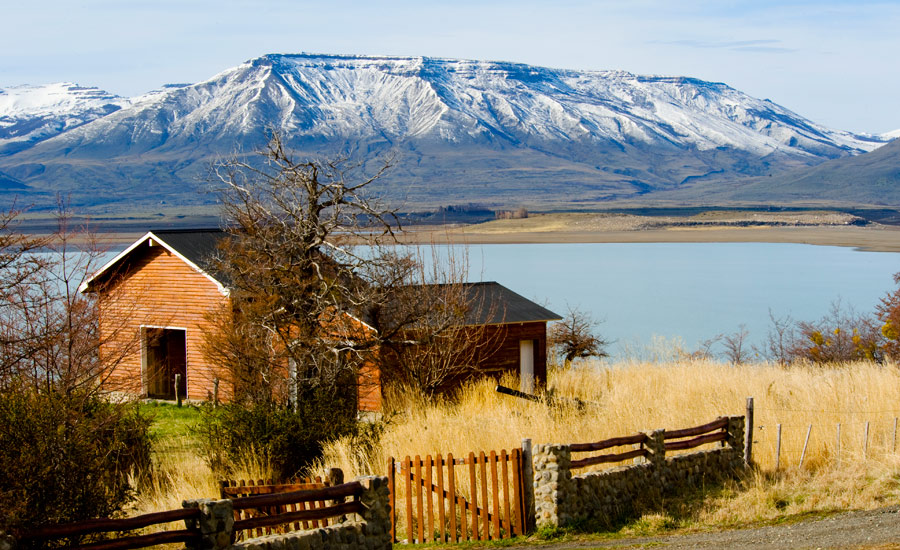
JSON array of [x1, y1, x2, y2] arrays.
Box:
[[533, 416, 745, 528]]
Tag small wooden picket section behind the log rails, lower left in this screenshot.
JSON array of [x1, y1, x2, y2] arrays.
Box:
[[219, 468, 344, 540]]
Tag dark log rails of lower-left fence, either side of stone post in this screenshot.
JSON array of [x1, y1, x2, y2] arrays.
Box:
[[16, 481, 364, 550]]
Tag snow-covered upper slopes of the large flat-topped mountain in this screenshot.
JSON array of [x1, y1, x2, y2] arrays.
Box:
[[17, 54, 884, 162]]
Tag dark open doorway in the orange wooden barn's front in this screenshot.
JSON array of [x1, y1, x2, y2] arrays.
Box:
[[144, 328, 187, 399]]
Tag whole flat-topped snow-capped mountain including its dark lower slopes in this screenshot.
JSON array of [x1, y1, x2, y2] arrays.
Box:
[[0, 55, 886, 211]]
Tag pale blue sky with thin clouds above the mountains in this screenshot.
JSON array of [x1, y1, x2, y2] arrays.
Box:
[[0, 0, 900, 133]]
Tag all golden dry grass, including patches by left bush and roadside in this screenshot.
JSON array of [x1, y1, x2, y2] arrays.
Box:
[[136, 360, 900, 527]]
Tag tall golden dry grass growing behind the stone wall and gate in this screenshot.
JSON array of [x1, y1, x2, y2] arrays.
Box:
[[323, 361, 900, 476]]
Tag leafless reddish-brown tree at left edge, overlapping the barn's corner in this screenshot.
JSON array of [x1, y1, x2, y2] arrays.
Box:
[[0, 205, 138, 395]]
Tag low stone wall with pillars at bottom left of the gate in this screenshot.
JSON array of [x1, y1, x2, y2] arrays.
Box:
[[184, 476, 392, 550]]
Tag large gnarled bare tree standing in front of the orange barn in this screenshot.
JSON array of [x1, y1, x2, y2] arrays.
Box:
[[208, 133, 397, 404]]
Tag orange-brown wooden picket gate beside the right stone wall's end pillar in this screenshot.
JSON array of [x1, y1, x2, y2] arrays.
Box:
[[388, 449, 525, 543]]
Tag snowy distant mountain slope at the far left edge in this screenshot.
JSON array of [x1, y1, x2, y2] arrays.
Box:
[[0, 82, 129, 153]]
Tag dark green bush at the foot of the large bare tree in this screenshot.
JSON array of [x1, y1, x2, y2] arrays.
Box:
[[197, 388, 357, 478]]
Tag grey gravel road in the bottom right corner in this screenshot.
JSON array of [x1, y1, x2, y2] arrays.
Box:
[[510, 506, 900, 550]]
